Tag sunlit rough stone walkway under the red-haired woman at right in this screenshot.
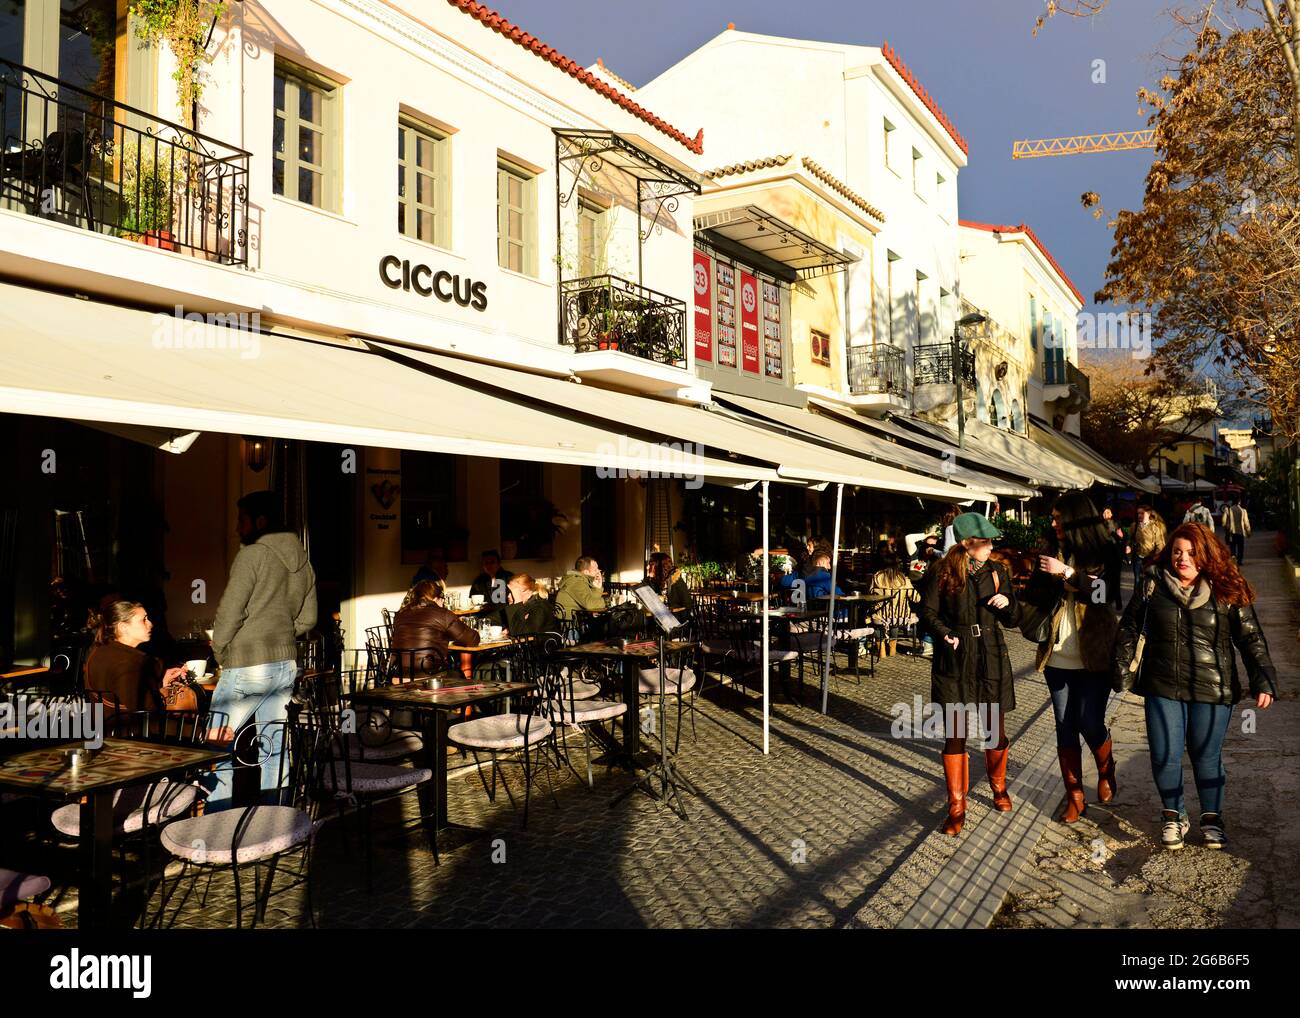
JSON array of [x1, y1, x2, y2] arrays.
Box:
[[993, 533, 1300, 928]]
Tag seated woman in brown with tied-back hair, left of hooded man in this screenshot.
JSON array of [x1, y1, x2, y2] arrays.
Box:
[[86, 601, 185, 711]]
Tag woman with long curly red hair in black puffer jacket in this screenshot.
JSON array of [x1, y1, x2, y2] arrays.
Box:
[[1114, 523, 1278, 849]]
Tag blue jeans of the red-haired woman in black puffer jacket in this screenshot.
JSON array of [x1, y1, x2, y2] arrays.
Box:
[[1147, 697, 1232, 815]]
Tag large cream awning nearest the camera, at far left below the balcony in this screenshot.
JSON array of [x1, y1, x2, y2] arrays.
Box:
[[0, 283, 780, 481]]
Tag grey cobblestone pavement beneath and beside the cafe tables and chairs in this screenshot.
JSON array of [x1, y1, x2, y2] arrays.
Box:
[[10, 613, 1052, 928]]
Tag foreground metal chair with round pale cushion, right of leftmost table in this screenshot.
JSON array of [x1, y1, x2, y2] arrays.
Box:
[[146, 705, 328, 928]]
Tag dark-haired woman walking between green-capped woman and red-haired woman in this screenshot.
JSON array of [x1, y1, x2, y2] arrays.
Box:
[[1021, 491, 1119, 823]]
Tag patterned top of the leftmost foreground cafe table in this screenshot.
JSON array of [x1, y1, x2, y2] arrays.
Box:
[[0, 738, 230, 798]]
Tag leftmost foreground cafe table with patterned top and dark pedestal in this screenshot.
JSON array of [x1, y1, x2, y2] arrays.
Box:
[[0, 738, 230, 930]]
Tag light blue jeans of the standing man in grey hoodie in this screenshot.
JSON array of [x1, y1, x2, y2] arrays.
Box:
[[204, 660, 298, 813]]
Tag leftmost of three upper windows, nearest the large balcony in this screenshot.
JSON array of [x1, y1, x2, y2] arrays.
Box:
[[272, 61, 339, 212]]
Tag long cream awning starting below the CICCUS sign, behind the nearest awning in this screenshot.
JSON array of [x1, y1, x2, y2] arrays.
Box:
[[367, 341, 971, 502]]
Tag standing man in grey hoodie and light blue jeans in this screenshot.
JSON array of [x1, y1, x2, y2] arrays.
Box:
[[207, 491, 316, 811]]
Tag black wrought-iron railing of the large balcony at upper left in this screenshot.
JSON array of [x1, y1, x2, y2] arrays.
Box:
[[0, 60, 248, 265]]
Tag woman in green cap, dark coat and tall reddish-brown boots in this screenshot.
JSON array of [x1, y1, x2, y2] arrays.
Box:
[[920, 512, 1021, 836]]
